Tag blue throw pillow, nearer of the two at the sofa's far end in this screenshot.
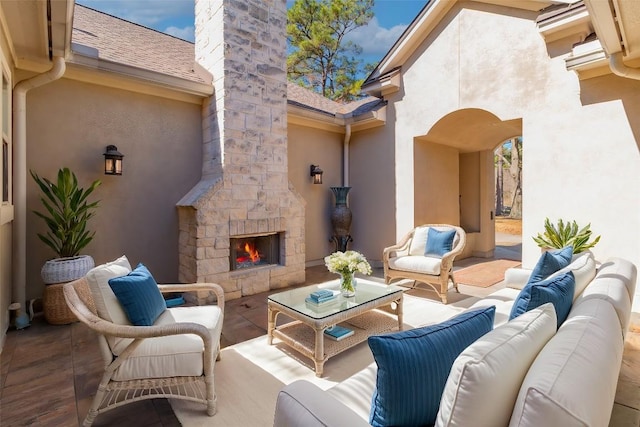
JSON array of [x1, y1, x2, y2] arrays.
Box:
[[509, 271, 576, 328]]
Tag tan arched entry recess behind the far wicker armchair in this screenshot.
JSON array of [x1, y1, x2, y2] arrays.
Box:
[[413, 108, 522, 258]]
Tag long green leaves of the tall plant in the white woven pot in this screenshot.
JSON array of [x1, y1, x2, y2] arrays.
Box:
[[30, 168, 101, 258]]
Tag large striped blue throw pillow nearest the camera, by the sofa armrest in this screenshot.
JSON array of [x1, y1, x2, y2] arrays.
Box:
[[368, 306, 496, 426]]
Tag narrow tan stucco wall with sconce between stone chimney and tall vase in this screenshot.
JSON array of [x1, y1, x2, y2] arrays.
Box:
[[287, 124, 344, 265]]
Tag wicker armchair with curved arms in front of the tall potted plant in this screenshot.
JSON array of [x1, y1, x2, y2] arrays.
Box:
[[64, 277, 224, 426]]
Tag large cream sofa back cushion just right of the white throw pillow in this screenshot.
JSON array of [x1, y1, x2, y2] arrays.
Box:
[[509, 299, 623, 427]]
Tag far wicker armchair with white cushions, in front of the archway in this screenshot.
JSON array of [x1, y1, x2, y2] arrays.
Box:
[[382, 224, 467, 304]]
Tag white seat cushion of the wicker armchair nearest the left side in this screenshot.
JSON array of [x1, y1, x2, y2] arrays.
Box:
[[113, 305, 222, 381]]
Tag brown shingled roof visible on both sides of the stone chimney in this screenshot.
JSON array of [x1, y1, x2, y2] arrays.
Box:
[[72, 3, 382, 116]]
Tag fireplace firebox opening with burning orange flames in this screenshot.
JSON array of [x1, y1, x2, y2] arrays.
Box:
[[229, 233, 280, 271]]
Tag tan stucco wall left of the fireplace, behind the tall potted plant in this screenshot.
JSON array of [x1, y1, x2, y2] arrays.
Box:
[[27, 79, 202, 299]]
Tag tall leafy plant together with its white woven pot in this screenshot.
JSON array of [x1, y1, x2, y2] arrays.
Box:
[[30, 168, 101, 284]]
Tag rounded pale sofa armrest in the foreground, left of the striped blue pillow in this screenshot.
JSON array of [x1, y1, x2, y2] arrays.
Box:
[[273, 380, 369, 427]]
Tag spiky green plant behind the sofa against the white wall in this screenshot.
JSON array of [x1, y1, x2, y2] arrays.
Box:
[[533, 218, 600, 254]]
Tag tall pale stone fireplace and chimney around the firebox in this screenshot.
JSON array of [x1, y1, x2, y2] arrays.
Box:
[[178, 0, 305, 299]]
